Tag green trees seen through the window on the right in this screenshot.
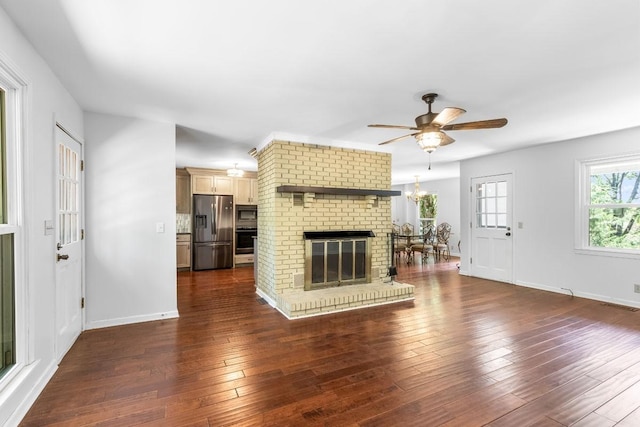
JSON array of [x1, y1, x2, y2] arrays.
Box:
[[589, 169, 640, 249]]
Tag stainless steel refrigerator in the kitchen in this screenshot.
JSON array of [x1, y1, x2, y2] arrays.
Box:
[[193, 194, 233, 270]]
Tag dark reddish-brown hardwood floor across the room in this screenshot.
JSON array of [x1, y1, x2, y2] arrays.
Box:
[[23, 261, 640, 427]]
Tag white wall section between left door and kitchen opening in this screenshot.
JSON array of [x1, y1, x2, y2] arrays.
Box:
[[85, 113, 177, 329]]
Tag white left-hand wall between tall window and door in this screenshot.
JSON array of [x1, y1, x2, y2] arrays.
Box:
[[0, 8, 83, 425]]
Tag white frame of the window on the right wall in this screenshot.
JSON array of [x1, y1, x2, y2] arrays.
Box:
[[575, 152, 640, 259]]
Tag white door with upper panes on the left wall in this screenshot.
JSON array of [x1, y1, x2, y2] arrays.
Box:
[[55, 127, 84, 360]]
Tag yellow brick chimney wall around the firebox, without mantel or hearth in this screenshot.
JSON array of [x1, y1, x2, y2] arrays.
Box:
[[256, 141, 391, 301]]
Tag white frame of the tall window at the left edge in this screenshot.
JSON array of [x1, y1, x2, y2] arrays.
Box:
[[0, 55, 28, 392]]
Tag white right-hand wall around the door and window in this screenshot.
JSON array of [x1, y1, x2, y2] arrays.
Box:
[[460, 128, 640, 306]]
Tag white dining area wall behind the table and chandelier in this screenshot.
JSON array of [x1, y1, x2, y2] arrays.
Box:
[[391, 178, 460, 255]]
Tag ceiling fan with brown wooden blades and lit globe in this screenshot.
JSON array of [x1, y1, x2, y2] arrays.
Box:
[[369, 93, 507, 153]]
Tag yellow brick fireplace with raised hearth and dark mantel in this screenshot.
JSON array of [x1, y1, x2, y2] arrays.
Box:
[[256, 140, 413, 318]]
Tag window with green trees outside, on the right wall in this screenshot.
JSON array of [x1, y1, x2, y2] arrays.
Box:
[[579, 154, 640, 255]]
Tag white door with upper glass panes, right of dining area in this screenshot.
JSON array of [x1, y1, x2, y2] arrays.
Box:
[[470, 174, 513, 283]]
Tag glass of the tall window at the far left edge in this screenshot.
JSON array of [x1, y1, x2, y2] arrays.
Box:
[[0, 87, 16, 377]]
